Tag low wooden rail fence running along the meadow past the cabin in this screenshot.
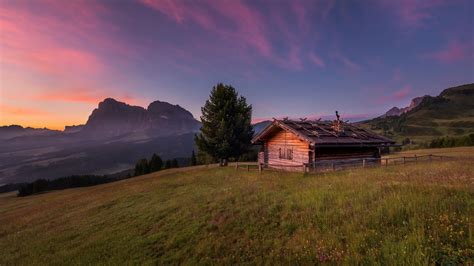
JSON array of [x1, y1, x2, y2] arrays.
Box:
[[235, 154, 456, 173]]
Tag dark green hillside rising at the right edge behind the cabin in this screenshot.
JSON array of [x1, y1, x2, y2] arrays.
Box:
[[362, 84, 474, 147]]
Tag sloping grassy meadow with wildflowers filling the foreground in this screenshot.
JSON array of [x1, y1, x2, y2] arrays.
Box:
[[0, 149, 474, 265]]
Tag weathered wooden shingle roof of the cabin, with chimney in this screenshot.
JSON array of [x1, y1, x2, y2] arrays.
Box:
[[252, 119, 395, 146]]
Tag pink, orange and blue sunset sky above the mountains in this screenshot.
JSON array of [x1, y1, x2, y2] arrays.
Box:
[[0, 0, 474, 129]]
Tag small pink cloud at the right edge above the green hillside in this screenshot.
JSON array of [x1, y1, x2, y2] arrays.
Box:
[[421, 41, 474, 63]]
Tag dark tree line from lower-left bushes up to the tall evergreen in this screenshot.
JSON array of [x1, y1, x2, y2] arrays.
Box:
[[12, 83, 258, 196]]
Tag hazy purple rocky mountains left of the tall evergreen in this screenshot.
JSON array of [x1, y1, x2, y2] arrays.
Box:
[[0, 98, 201, 185]]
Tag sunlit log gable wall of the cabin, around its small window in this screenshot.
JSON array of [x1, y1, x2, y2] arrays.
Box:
[[265, 130, 309, 166]]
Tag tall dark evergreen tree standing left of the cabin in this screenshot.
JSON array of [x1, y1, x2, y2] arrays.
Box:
[[195, 83, 253, 165]]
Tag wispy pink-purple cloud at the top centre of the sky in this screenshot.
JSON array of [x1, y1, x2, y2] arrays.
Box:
[[139, 0, 334, 70]]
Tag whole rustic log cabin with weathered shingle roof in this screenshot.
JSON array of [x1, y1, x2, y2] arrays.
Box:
[[252, 117, 395, 171]]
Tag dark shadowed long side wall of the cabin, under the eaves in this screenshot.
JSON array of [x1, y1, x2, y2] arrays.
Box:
[[316, 147, 380, 161]]
